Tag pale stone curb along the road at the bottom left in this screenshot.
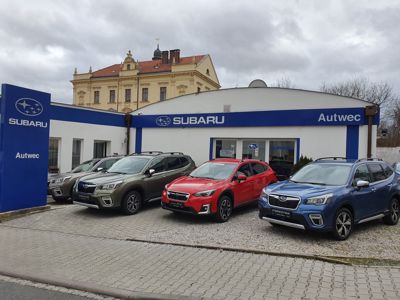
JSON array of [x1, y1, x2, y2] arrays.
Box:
[[0, 270, 201, 300]]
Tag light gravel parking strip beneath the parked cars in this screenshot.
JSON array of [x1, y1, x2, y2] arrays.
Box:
[[4, 203, 400, 261]]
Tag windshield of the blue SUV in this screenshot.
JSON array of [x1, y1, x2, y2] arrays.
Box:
[[290, 163, 351, 185]]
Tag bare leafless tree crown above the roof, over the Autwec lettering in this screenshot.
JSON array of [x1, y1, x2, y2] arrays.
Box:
[[320, 77, 398, 106]]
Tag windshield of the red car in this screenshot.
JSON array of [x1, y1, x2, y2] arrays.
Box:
[[190, 162, 237, 180]]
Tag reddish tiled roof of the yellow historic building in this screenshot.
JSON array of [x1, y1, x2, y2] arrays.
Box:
[[92, 55, 205, 78]]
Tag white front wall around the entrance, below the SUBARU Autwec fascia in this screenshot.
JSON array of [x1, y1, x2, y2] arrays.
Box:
[[142, 126, 346, 165]]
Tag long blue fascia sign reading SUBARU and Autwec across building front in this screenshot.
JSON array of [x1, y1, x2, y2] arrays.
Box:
[[132, 107, 379, 128]]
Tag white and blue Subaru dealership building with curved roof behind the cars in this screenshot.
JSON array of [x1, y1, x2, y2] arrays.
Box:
[[50, 87, 379, 172]]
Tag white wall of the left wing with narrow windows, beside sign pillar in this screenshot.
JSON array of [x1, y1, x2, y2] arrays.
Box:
[[50, 120, 126, 172]]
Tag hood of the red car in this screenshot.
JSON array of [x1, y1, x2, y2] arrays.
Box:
[[167, 176, 225, 194]]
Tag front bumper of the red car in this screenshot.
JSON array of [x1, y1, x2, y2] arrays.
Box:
[[161, 191, 217, 215]]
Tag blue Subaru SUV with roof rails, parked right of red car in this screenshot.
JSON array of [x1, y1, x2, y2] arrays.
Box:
[[258, 157, 400, 240]]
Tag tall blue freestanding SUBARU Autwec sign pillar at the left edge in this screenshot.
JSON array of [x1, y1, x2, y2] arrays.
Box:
[[0, 84, 50, 212]]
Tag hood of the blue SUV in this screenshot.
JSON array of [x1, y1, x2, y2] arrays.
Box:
[[266, 180, 343, 198]]
